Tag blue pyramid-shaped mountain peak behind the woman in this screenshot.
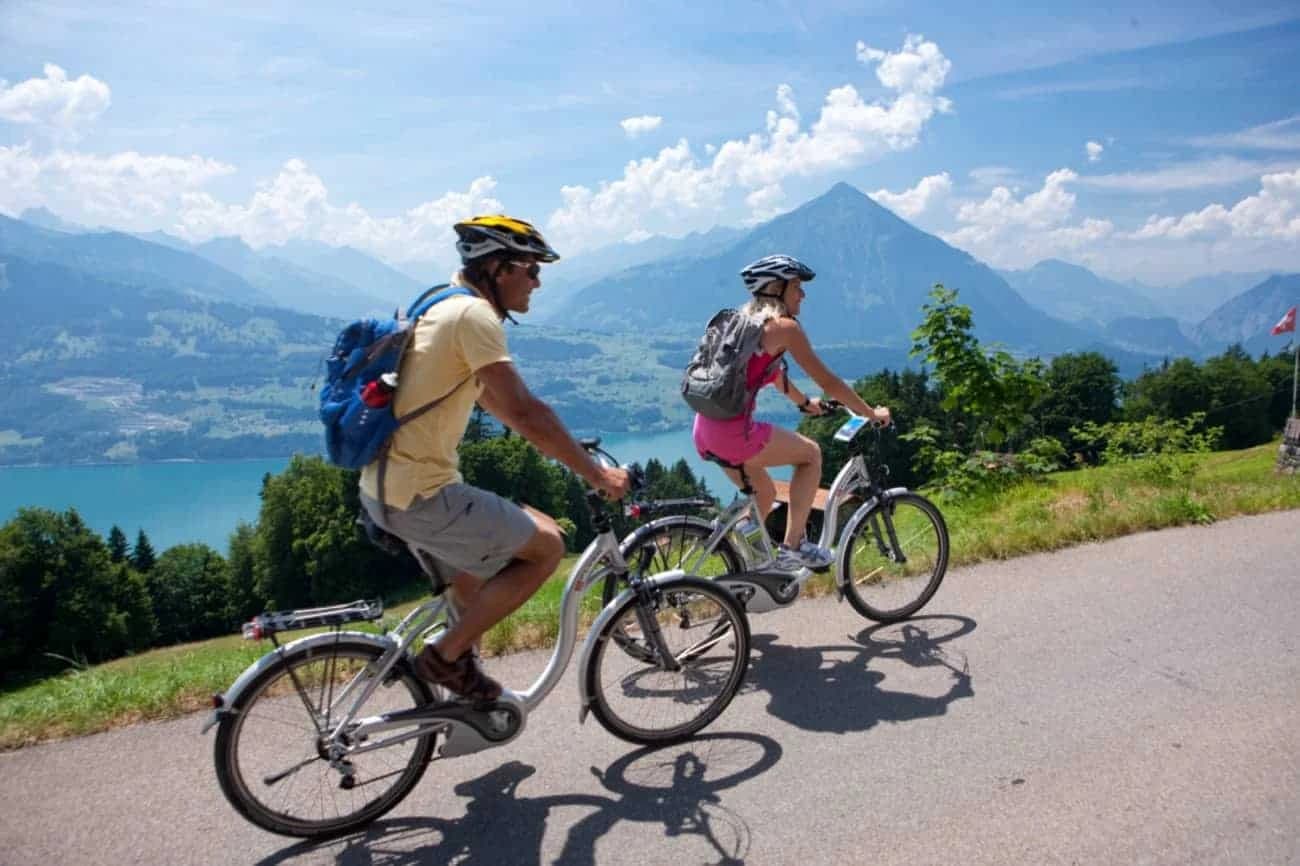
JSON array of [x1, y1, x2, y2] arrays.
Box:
[[553, 183, 1092, 352]]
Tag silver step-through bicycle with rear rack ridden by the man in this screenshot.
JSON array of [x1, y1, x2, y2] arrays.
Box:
[[203, 440, 749, 837]]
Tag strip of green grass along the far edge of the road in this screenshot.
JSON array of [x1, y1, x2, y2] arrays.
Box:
[[0, 442, 1300, 749]]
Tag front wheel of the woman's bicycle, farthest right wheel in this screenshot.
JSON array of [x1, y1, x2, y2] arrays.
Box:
[[840, 492, 948, 623]]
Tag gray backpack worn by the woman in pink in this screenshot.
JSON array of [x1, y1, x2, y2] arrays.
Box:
[[681, 309, 781, 420]]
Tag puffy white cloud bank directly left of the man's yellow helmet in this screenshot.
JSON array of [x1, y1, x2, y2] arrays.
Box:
[[177, 159, 503, 261]]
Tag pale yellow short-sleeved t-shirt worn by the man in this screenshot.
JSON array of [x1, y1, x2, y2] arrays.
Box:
[[361, 289, 510, 508]]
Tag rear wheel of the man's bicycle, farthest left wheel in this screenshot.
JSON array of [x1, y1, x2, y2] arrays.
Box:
[[215, 638, 434, 837]]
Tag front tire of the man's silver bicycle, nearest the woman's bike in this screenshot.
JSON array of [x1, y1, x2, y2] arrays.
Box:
[[582, 577, 750, 745]]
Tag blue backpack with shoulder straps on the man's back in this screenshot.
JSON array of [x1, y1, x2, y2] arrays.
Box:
[[320, 286, 473, 473]]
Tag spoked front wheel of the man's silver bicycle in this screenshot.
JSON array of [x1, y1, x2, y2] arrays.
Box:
[[584, 577, 749, 745]]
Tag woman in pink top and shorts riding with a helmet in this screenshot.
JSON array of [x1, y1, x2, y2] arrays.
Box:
[[693, 255, 889, 571]]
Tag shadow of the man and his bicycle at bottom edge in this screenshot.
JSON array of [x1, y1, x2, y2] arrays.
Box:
[[259, 733, 781, 866]]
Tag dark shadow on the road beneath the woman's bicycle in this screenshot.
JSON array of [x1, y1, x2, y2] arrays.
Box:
[[750, 615, 975, 733]]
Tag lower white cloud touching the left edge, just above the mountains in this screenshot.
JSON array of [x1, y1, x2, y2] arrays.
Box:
[[0, 144, 235, 223]]
